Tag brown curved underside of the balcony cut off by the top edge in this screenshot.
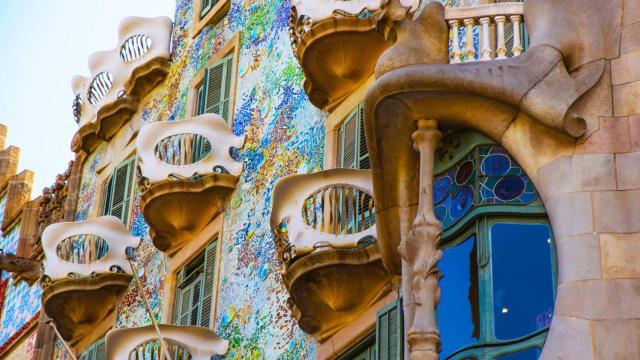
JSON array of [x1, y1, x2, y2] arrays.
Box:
[[296, 15, 392, 111]]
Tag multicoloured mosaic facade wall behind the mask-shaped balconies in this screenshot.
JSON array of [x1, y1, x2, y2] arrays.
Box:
[[72, 0, 324, 359]]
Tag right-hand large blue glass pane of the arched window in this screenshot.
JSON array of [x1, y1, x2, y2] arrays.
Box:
[[490, 223, 553, 340]]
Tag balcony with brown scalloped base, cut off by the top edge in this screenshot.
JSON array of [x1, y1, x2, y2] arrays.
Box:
[[290, 0, 419, 111]]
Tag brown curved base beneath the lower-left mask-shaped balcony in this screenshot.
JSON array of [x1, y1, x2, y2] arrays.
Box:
[[42, 273, 133, 353]]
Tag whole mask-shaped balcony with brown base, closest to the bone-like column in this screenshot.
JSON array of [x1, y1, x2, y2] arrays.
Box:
[[270, 169, 391, 341]]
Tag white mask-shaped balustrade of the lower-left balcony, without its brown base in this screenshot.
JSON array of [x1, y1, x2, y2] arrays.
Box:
[[42, 216, 140, 284]]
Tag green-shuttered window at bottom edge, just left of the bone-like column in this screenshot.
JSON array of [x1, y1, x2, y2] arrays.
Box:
[[338, 300, 404, 360]]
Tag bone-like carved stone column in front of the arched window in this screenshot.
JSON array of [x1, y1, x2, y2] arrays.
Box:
[[398, 120, 442, 360]]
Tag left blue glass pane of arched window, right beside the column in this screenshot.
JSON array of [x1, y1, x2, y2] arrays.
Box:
[[436, 235, 480, 359]]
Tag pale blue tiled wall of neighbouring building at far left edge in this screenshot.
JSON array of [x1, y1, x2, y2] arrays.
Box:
[[0, 196, 42, 351]]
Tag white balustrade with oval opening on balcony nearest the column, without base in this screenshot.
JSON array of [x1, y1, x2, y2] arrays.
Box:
[[271, 169, 376, 263]]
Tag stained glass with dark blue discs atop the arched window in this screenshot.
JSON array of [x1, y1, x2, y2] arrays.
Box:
[[433, 145, 538, 229]]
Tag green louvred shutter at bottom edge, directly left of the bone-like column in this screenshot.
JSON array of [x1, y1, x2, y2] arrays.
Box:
[[376, 300, 404, 360]]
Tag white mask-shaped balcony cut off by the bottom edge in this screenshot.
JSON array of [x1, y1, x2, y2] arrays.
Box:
[[106, 325, 229, 360]]
